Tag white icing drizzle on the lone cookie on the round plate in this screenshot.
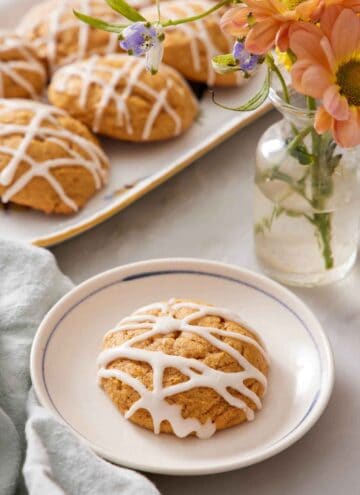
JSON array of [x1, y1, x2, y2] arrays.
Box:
[[98, 299, 268, 438]]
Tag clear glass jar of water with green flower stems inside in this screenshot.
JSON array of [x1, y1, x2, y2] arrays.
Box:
[[254, 90, 360, 286]]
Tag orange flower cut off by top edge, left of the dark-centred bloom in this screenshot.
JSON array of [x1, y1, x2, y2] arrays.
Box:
[[221, 0, 322, 55]]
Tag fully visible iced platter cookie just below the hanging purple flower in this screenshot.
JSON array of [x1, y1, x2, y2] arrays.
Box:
[[49, 54, 197, 141]]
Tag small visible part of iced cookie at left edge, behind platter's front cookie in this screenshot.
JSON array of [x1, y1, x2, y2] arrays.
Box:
[[0, 30, 47, 100]]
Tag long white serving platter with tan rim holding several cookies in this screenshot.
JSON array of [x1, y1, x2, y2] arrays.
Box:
[[0, 0, 270, 246]]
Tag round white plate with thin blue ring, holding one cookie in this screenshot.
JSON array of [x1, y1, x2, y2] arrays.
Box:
[[31, 258, 334, 475]]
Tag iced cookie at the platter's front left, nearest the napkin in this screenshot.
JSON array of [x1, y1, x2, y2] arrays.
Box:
[[0, 99, 108, 214]]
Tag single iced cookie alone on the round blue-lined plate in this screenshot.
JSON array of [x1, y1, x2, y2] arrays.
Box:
[[98, 299, 268, 438]]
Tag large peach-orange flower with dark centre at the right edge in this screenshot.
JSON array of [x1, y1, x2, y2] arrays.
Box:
[[289, 5, 360, 147]]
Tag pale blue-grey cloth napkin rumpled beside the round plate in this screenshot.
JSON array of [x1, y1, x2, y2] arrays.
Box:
[[0, 240, 159, 495]]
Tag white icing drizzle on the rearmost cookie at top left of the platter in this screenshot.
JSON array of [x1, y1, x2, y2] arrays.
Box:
[[18, 0, 118, 73]]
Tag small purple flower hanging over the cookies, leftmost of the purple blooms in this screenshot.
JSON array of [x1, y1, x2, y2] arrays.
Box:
[[120, 22, 161, 57]]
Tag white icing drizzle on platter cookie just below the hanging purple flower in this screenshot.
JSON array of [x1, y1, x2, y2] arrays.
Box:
[[52, 54, 182, 140]]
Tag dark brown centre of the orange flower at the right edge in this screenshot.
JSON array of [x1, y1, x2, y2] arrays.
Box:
[[336, 57, 360, 107]]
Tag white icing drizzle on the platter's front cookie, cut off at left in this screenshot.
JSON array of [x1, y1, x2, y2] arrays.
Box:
[[0, 99, 108, 211]]
